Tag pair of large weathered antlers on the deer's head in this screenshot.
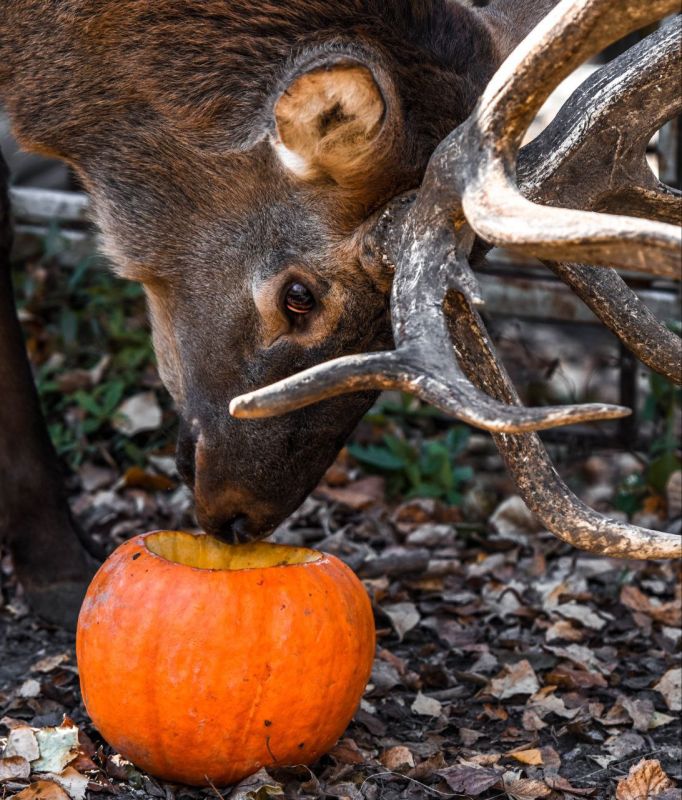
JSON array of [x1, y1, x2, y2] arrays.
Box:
[[230, 0, 682, 558]]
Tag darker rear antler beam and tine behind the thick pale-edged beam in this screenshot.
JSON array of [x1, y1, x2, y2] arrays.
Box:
[[518, 22, 682, 383]]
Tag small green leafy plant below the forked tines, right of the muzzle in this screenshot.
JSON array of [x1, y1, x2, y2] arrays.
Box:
[[348, 425, 473, 505]]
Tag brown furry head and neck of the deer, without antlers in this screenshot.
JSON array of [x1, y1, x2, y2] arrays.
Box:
[[0, 0, 552, 538]]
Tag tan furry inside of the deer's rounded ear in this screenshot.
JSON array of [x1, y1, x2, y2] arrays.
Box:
[[274, 63, 386, 187]]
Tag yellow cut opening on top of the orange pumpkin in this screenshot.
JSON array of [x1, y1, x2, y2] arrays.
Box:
[[144, 531, 322, 570]]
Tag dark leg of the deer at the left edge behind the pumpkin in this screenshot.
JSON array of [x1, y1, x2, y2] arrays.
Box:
[[0, 156, 94, 627]]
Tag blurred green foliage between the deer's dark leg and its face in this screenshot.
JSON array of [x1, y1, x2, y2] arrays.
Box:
[[14, 226, 175, 470]]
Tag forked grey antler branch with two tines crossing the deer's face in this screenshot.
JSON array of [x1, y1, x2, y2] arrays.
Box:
[[230, 216, 630, 433]]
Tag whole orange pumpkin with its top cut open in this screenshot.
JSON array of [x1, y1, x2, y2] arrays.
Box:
[[76, 531, 375, 785]]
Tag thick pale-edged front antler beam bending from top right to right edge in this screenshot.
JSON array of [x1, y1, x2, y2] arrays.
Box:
[[448, 0, 682, 278]]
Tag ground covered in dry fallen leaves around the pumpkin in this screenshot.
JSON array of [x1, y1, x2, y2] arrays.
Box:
[[0, 459, 682, 800]]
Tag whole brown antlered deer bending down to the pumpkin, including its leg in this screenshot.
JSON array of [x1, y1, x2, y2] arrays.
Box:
[[0, 0, 682, 632]]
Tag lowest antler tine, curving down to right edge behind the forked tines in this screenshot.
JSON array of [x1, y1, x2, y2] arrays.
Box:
[[446, 292, 682, 559]]
